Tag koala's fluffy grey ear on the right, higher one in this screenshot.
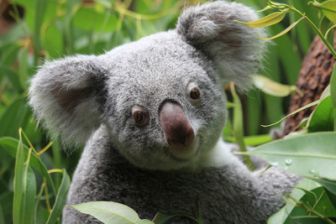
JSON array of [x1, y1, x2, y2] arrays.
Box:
[[176, 1, 265, 90]]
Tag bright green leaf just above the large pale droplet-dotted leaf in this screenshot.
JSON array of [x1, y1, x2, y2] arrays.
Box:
[[308, 96, 334, 132]]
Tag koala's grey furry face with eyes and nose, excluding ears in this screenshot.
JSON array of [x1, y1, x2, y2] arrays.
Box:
[[101, 32, 225, 169]]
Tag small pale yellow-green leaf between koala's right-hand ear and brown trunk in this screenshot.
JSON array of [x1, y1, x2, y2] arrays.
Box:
[[253, 75, 296, 97]]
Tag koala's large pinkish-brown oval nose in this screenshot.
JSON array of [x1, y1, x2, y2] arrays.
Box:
[[159, 101, 195, 150]]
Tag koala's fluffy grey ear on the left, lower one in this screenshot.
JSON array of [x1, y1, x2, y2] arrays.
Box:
[[29, 56, 106, 144]]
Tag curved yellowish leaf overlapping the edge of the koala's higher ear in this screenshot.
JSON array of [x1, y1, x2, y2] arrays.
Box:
[[239, 10, 288, 28]]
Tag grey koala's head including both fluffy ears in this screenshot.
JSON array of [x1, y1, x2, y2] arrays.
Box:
[[30, 1, 264, 170]]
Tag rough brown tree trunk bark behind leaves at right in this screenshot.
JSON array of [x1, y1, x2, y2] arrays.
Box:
[[283, 37, 335, 135]]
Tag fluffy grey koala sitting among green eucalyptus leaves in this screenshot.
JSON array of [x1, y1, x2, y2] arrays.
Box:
[[29, 1, 297, 224]]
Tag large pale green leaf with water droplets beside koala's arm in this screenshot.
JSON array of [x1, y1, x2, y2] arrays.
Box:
[[248, 132, 336, 179]]
